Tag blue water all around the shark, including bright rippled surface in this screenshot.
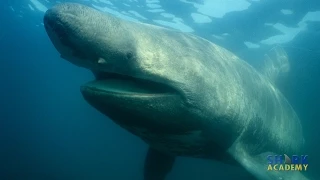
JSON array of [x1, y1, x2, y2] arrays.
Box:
[[0, 0, 320, 180]]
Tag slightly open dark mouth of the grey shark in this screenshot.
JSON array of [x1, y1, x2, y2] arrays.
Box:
[[81, 72, 176, 95]]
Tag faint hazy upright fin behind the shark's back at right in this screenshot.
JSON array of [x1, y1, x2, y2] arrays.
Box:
[[262, 45, 290, 83]]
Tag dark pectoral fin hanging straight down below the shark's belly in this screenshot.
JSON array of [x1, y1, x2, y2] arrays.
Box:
[[144, 148, 175, 180]]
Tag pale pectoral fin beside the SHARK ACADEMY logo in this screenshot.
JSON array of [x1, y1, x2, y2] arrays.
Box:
[[229, 145, 309, 180]]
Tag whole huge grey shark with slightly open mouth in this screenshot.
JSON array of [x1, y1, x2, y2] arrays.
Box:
[[44, 3, 307, 180]]
